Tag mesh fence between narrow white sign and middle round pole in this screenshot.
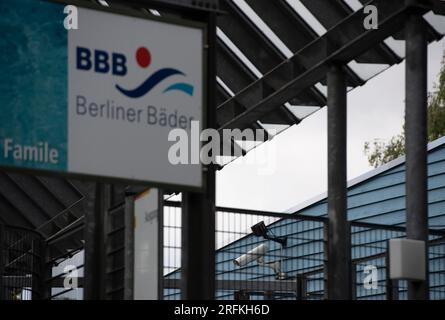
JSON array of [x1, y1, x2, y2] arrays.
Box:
[[164, 202, 327, 300]]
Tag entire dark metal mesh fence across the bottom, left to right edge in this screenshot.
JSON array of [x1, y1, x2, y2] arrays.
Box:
[[0, 201, 445, 300]]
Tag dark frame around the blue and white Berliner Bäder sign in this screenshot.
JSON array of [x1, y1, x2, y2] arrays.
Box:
[[0, 0, 210, 193]]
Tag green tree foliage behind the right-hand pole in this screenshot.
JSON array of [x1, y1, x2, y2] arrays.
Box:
[[364, 55, 445, 168]]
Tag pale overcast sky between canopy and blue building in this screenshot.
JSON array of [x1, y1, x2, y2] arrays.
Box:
[[217, 37, 445, 211]]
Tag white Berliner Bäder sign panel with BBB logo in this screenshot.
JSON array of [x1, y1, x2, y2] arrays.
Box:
[[67, 8, 204, 188]]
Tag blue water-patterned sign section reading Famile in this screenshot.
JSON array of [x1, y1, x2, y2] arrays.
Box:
[[0, 0, 68, 171]]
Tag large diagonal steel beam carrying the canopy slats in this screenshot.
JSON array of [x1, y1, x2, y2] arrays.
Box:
[[220, 0, 426, 129]]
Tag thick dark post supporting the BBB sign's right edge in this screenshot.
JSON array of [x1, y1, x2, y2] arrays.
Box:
[[181, 13, 216, 300]]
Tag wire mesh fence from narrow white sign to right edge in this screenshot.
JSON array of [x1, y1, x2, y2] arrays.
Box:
[[163, 202, 445, 300]]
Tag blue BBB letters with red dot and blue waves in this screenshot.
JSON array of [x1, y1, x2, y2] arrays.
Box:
[[76, 47, 194, 98]]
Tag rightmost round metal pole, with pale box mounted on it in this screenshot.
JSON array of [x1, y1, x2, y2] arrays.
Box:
[[405, 12, 428, 300]]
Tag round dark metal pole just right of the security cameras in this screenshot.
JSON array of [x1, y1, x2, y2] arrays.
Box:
[[327, 64, 352, 299]]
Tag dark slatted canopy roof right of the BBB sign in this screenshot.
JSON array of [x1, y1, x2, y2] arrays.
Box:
[[112, 0, 445, 166]]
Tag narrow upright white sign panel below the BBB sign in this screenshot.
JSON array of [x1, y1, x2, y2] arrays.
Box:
[[133, 189, 159, 300]]
